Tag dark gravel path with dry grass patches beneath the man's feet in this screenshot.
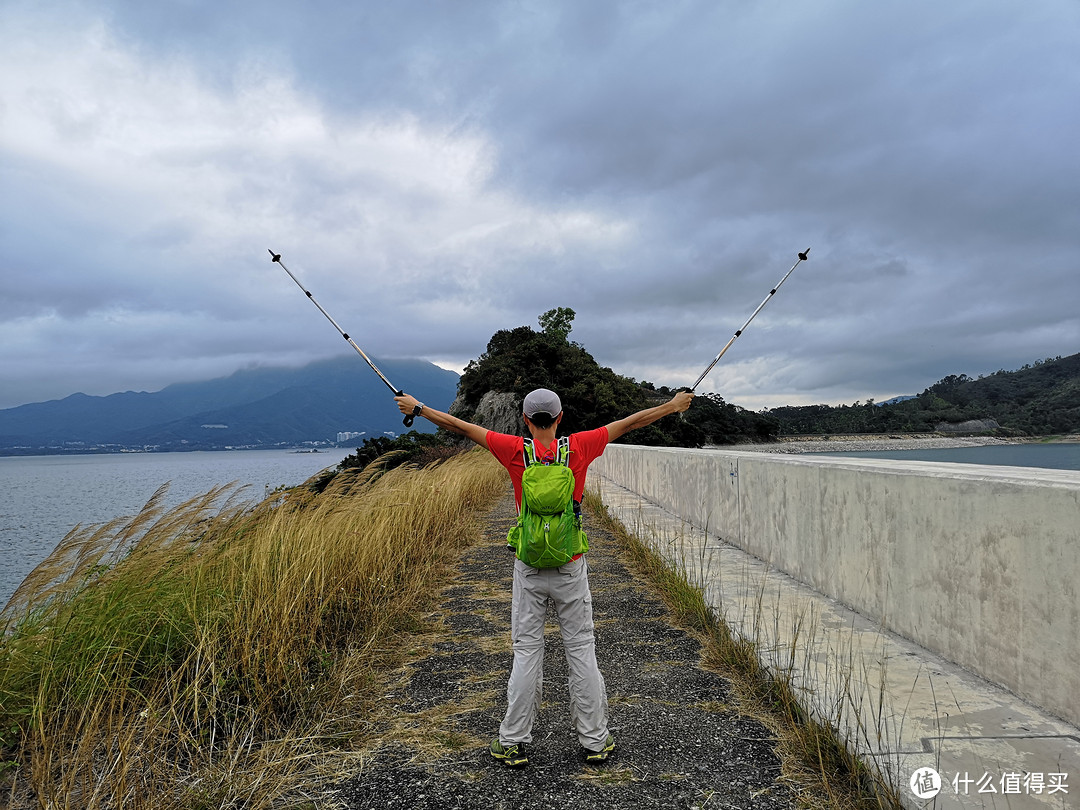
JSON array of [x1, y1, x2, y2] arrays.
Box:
[[337, 487, 797, 810]]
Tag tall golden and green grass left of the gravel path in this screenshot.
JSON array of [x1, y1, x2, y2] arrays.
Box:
[[0, 453, 504, 808]]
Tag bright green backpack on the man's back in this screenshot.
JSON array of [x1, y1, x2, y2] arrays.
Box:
[[507, 438, 589, 568]]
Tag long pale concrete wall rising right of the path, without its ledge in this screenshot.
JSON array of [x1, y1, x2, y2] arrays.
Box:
[[592, 445, 1080, 724]]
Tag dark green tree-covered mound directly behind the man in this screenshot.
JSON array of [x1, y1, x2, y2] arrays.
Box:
[[458, 307, 777, 447]]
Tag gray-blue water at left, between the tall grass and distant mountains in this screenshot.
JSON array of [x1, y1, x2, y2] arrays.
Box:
[[0, 448, 352, 607]]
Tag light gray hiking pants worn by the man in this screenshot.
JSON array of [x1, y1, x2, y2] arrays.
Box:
[[499, 556, 608, 751]]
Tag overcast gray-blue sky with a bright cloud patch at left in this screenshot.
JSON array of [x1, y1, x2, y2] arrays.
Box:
[[0, 0, 1080, 409]]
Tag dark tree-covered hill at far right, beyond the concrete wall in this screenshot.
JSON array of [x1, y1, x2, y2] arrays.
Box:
[[768, 354, 1080, 435]]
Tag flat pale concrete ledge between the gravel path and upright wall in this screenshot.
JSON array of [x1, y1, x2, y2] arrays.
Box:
[[589, 474, 1080, 810]]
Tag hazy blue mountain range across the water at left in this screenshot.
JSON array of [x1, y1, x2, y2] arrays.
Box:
[[0, 355, 458, 456]]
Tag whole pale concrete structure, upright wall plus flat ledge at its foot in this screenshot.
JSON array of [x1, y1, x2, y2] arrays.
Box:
[[590, 446, 1080, 808]]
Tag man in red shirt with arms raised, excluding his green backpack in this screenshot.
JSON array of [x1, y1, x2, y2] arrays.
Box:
[[394, 388, 693, 768]]
